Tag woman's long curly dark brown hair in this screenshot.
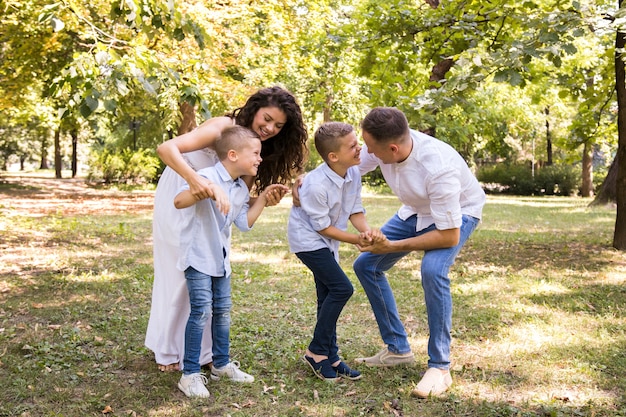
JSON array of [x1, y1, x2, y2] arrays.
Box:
[[228, 86, 308, 192]]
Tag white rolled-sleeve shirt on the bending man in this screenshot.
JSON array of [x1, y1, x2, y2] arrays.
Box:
[[359, 130, 486, 231]]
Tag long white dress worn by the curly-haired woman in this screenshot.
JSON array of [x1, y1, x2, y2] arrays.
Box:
[[145, 148, 219, 369]]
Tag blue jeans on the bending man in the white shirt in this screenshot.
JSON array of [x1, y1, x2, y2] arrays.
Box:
[[354, 214, 480, 369]]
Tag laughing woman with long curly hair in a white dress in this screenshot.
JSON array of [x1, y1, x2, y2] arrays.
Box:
[[145, 87, 307, 371]]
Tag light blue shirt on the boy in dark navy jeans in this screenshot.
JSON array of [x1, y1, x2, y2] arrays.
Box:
[[287, 163, 365, 261]]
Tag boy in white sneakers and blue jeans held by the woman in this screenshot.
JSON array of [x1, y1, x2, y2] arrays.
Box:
[[174, 126, 288, 398]]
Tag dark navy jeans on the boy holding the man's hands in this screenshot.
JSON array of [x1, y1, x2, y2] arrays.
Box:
[[296, 248, 354, 363]]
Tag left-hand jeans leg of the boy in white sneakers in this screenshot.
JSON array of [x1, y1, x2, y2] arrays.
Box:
[[183, 267, 212, 375]]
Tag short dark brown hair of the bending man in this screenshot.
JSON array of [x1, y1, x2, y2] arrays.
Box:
[[361, 107, 409, 143]]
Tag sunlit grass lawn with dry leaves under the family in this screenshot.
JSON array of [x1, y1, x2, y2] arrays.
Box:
[[0, 176, 626, 417]]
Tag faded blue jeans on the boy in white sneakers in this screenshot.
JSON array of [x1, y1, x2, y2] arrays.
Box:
[[183, 267, 233, 375]]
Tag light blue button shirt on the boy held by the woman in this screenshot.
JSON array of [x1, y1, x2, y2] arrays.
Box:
[[176, 162, 251, 277]]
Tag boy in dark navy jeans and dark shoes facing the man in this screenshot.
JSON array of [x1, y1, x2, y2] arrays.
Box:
[[287, 122, 384, 382]]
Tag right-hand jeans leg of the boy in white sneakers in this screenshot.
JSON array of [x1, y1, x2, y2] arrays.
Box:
[[211, 275, 233, 368]]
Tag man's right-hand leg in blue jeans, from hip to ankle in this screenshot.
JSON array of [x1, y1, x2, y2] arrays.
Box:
[[421, 216, 479, 370]]
